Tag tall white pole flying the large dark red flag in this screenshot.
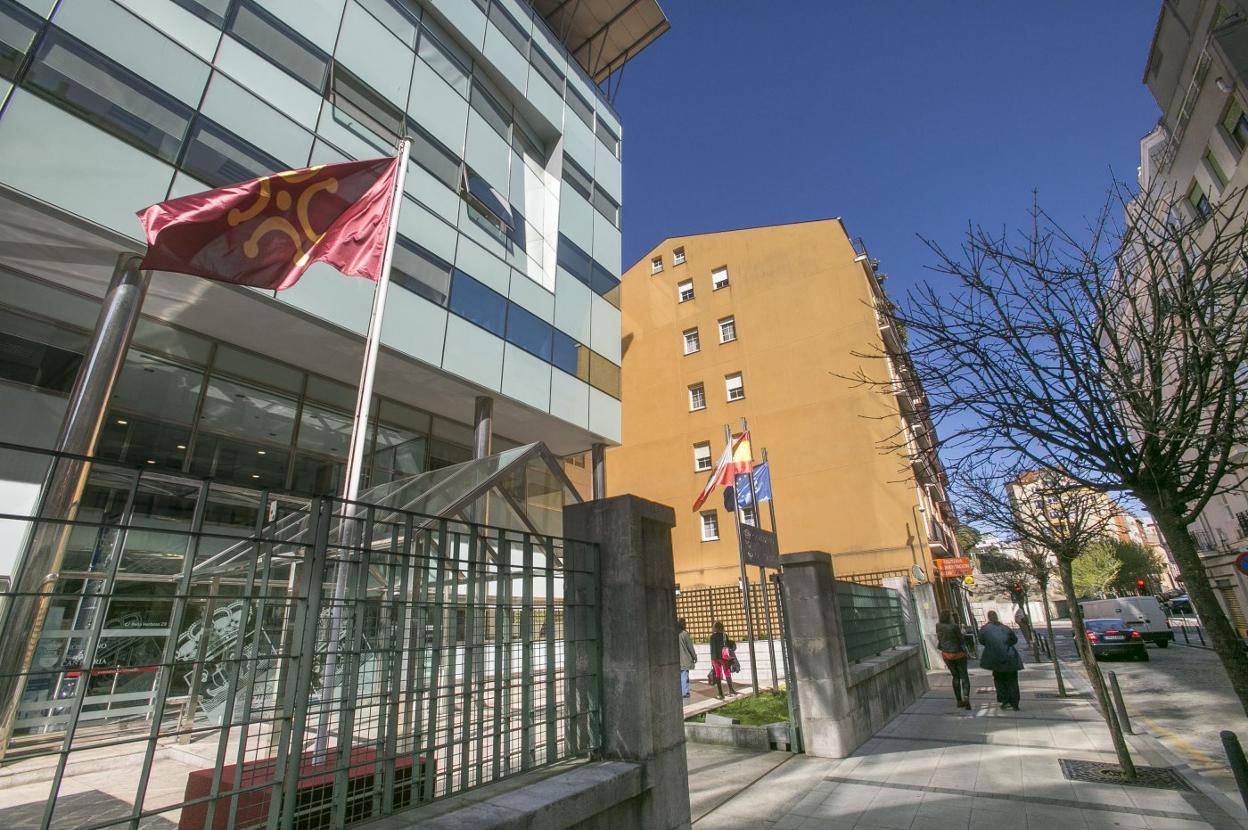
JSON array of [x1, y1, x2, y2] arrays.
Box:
[[312, 139, 412, 764]]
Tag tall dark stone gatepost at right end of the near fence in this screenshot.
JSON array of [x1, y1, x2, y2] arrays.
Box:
[[563, 496, 690, 830]]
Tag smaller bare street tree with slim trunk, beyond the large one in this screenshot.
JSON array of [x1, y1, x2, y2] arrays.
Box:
[[952, 461, 1136, 780]]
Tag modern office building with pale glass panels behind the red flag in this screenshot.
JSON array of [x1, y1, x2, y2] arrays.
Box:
[[0, 0, 665, 574]]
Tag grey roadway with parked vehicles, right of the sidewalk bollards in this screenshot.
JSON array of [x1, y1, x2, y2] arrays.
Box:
[[1025, 620, 1248, 793]]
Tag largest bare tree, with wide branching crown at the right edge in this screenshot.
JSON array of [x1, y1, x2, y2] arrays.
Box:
[[857, 186, 1248, 713]]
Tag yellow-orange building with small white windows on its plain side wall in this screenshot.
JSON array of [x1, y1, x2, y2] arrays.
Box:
[[607, 218, 956, 590]]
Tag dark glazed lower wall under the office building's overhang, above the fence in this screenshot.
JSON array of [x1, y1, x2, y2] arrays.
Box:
[[0, 305, 496, 496]]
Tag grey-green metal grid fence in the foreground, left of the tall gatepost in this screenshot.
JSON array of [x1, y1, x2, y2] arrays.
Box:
[[0, 454, 600, 830]]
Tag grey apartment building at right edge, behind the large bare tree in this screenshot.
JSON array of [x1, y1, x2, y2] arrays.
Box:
[[1139, 0, 1248, 637]]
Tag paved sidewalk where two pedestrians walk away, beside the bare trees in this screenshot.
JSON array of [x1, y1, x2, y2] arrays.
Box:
[[688, 664, 1248, 830]]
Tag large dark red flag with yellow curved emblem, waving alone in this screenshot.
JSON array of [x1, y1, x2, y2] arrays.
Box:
[[139, 159, 398, 291]]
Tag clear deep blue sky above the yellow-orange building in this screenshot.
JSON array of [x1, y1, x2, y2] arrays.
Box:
[[617, 0, 1159, 298]]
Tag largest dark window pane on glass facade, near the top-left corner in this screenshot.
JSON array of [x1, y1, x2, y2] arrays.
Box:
[[25, 29, 192, 162]]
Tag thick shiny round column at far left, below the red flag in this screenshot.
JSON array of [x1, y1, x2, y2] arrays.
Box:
[[0, 253, 150, 758]]
